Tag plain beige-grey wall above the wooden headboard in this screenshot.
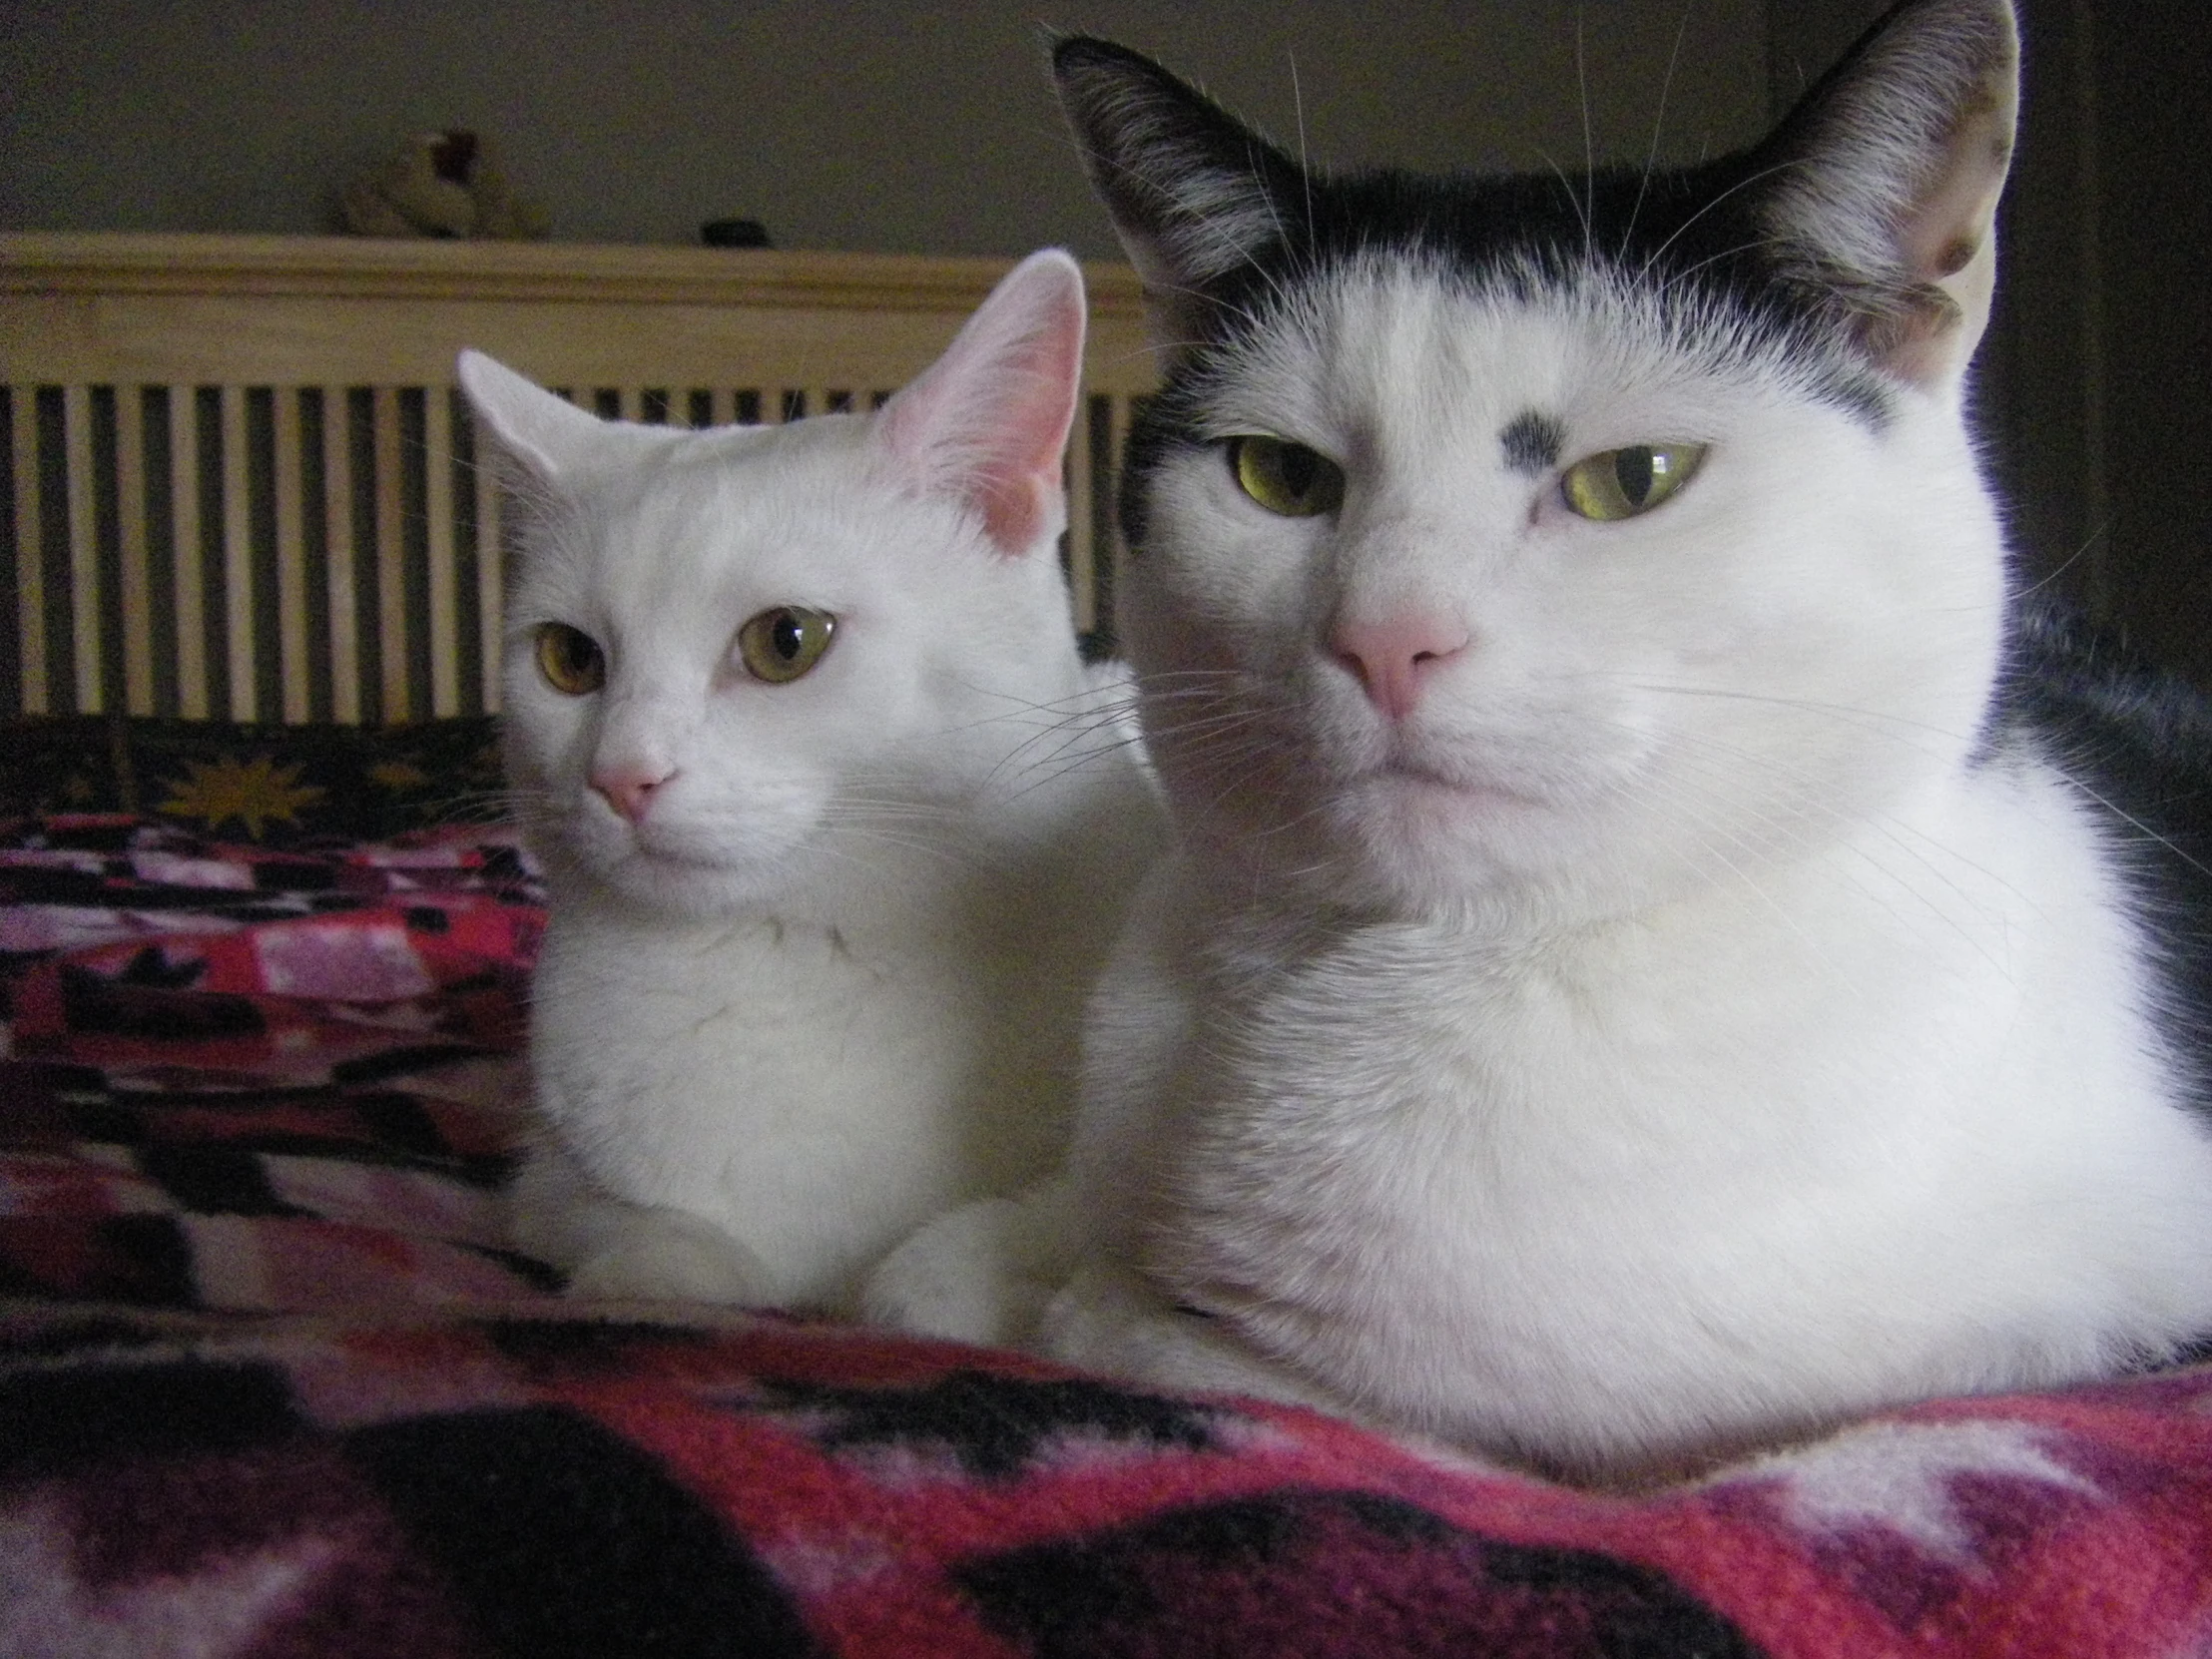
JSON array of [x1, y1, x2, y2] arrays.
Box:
[[0, 0, 1770, 257]]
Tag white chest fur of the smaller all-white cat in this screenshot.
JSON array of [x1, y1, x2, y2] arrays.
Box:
[[533, 848, 1082, 1303]]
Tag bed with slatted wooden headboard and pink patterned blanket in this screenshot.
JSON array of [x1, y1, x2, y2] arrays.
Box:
[[0, 235, 2212, 1659]]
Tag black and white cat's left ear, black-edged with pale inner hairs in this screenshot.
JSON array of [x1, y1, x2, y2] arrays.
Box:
[[1053, 35, 1305, 338]]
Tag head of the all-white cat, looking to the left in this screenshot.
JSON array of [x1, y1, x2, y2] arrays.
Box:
[[460, 250, 1084, 915]]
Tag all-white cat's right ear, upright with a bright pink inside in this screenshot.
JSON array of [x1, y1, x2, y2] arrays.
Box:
[[878, 248, 1086, 557]]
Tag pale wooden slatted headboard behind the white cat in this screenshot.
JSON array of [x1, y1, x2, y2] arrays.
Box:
[[0, 233, 1153, 721]]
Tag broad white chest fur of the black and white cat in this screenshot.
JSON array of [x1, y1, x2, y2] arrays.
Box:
[[1114, 775, 2212, 1462]]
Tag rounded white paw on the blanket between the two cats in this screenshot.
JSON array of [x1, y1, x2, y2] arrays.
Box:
[[860, 1192, 1068, 1348]]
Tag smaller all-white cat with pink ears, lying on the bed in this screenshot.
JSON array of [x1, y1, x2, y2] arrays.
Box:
[[460, 253, 1157, 1310]]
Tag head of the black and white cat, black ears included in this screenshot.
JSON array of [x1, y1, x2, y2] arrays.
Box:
[[1055, 0, 2017, 924]]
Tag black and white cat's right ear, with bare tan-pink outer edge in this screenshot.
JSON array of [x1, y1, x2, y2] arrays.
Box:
[[1757, 0, 2019, 385]]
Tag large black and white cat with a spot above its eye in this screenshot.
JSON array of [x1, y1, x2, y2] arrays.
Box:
[[875, 0, 2212, 1473]]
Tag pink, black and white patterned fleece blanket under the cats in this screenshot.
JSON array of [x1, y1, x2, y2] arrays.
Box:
[[0, 819, 2212, 1659]]
